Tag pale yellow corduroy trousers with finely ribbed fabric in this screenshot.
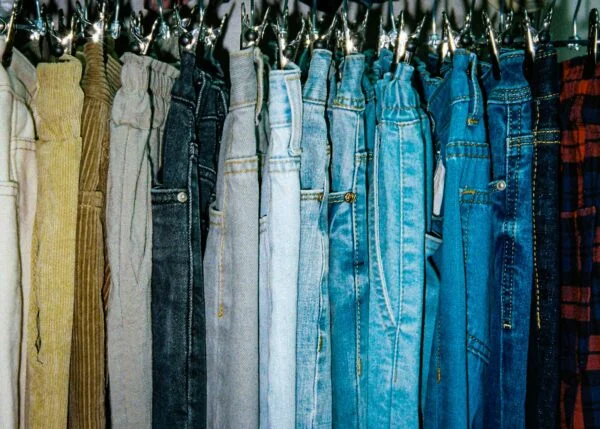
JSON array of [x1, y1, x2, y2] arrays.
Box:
[[27, 56, 83, 429]]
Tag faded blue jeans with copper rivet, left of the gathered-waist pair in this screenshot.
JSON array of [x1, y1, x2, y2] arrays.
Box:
[[329, 54, 369, 428]]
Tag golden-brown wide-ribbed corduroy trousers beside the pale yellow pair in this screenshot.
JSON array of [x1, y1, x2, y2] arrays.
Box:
[[69, 42, 113, 429]]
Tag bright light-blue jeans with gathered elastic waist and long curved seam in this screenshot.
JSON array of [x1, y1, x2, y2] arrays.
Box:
[[368, 63, 430, 428]]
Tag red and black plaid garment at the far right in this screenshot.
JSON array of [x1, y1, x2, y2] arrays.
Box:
[[560, 58, 600, 428]]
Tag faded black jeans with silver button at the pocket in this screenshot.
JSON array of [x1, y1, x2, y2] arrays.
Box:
[[152, 53, 227, 428]]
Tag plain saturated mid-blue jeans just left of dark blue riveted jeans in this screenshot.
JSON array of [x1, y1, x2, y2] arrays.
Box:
[[424, 50, 494, 428]]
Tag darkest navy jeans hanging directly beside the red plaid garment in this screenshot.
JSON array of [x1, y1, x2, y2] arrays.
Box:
[[525, 46, 560, 429]]
